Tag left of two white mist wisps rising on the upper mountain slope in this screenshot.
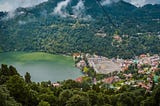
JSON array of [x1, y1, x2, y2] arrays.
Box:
[[53, 0, 71, 17]]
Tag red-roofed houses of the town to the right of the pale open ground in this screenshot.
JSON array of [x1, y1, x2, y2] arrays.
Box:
[[102, 54, 160, 91]]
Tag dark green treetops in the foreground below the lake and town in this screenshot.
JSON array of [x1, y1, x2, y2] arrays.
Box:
[[0, 64, 160, 106]]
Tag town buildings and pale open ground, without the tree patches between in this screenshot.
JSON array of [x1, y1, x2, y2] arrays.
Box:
[[73, 54, 160, 90]]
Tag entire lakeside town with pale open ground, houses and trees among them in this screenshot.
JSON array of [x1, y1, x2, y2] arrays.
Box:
[[73, 53, 160, 91]]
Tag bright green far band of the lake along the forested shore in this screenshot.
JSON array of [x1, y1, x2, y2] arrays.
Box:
[[0, 52, 73, 64]]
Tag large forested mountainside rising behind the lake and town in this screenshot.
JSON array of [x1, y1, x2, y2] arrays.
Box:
[[0, 0, 160, 58]]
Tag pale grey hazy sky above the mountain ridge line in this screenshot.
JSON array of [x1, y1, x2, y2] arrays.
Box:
[[0, 0, 160, 11]]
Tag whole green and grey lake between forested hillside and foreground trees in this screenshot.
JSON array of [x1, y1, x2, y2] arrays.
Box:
[[0, 52, 82, 82]]
